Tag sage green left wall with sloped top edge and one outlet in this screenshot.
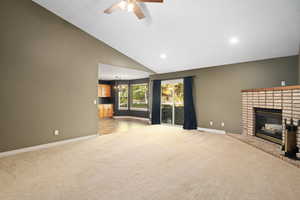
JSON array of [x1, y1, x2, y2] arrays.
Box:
[[0, 0, 150, 152]]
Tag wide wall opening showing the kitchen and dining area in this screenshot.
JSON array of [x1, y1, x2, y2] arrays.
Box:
[[96, 64, 149, 135]]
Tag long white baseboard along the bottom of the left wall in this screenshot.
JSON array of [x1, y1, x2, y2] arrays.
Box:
[[0, 134, 99, 158]]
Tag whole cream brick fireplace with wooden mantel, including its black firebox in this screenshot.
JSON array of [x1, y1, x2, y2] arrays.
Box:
[[242, 86, 300, 157]]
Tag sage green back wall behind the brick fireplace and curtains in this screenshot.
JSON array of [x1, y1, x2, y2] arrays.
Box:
[[151, 56, 298, 133]]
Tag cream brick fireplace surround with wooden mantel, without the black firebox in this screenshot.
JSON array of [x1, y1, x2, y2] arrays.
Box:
[[241, 85, 300, 157]]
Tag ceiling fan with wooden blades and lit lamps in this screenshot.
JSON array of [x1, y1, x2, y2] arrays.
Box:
[[104, 0, 163, 19]]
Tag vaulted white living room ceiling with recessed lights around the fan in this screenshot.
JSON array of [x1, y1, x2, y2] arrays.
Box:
[[34, 0, 300, 73]]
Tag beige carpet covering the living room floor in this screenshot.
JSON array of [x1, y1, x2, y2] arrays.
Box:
[[0, 126, 300, 200]]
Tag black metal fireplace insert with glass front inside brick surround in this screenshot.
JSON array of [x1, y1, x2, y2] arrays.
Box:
[[254, 108, 283, 145]]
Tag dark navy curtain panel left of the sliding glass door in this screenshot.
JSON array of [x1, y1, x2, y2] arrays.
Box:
[[151, 80, 161, 124]]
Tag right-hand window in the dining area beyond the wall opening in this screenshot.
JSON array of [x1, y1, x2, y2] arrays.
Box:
[[130, 83, 149, 110]]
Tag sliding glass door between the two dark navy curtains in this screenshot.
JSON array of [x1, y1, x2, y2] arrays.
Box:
[[161, 79, 184, 125]]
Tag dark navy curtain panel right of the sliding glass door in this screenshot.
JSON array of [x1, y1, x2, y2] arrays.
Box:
[[183, 77, 197, 130]]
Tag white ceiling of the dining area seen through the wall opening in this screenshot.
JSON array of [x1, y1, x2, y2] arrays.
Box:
[[98, 64, 150, 80]]
